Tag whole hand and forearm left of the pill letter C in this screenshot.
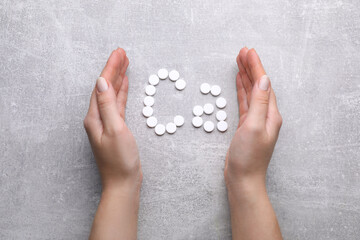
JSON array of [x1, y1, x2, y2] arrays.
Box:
[[84, 48, 142, 240]]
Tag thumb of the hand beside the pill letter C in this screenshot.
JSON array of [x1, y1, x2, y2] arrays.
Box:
[[96, 77, 120, 133]]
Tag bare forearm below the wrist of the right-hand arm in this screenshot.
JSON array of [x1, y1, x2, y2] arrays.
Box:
[[228, 176, 282, 240]]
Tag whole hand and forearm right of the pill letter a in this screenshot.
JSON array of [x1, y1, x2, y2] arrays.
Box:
[[224, 47, 282, 240]]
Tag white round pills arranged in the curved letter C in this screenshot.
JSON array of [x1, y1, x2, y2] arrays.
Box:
[[142, 68, 186, 136]]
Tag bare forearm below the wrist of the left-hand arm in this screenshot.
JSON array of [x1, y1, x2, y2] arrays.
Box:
[[89, 186, 140, 240]]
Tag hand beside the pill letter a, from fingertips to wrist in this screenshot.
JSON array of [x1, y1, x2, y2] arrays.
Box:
[[224, 48, 282, 192]]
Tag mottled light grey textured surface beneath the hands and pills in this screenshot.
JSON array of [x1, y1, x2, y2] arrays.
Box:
[[0, 0, 360, 239]]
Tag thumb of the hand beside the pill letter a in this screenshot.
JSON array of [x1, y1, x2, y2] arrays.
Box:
[[248, 75, 270, 126]]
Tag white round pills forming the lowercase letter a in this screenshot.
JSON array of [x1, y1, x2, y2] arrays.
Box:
[[192, 83, 228, 133]]
